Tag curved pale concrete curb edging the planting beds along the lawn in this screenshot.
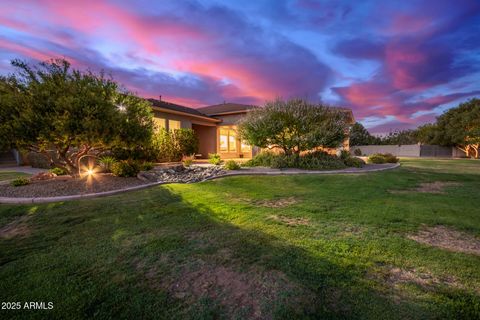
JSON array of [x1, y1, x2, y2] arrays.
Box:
[[0, 163, 400, 204]]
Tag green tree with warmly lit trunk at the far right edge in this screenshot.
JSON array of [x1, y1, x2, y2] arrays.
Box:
[[433, 98, 480, 159]]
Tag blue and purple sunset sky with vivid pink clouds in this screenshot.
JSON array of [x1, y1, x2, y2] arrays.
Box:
[[0, 0, 480, 133]]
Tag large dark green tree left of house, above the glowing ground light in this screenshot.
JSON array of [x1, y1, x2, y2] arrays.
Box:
[[0, 60, 153, 173]]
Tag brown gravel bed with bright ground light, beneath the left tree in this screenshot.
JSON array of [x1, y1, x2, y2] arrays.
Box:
[[0, 174, 148, 198]]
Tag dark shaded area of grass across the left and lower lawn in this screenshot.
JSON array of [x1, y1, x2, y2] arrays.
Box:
[[0, 187, 479, 319]]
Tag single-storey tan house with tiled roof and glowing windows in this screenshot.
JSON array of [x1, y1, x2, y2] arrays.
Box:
[[148, 99, 355, 159]]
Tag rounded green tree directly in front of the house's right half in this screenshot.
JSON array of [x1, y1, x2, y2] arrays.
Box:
[[239, 99, 348, 155]]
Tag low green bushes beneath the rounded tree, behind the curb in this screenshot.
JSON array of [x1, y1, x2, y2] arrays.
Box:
[[244, 151, 345, 170]]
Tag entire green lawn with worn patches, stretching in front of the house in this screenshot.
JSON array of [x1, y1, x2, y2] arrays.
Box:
[[0, 159, 480, 319]]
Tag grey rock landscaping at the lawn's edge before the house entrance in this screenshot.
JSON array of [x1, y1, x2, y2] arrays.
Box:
[[137, 165, 226, 183]]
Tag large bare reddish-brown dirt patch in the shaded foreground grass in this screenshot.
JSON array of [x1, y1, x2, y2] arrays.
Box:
[[169, 263, 308, 319]]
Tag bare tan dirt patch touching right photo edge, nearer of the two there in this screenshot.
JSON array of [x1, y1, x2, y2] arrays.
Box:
[[407, 226, 480, 255]]
